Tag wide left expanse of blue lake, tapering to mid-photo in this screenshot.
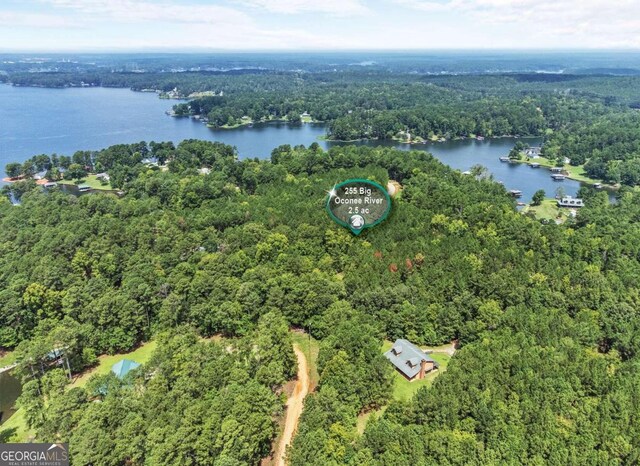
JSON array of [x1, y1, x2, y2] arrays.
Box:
[[0, 85, 324, 162]]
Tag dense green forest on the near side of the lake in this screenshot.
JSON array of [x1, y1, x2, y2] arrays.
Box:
[[0, 140, 640, 465]]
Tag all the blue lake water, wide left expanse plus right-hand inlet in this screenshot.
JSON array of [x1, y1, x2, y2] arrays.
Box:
[[0, 85, 592, 201]]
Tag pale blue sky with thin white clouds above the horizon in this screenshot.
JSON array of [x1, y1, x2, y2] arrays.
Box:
[[0, 0, 640, 51]]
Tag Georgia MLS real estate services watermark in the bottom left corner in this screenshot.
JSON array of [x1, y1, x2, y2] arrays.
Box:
[[0, 443, 69, 466]]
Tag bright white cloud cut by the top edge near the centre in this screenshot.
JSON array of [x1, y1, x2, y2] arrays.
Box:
[[234, 0, 370, 16]]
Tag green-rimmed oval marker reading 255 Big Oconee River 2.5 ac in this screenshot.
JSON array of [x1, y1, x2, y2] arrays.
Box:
[[327, 178, 391, 235]]
